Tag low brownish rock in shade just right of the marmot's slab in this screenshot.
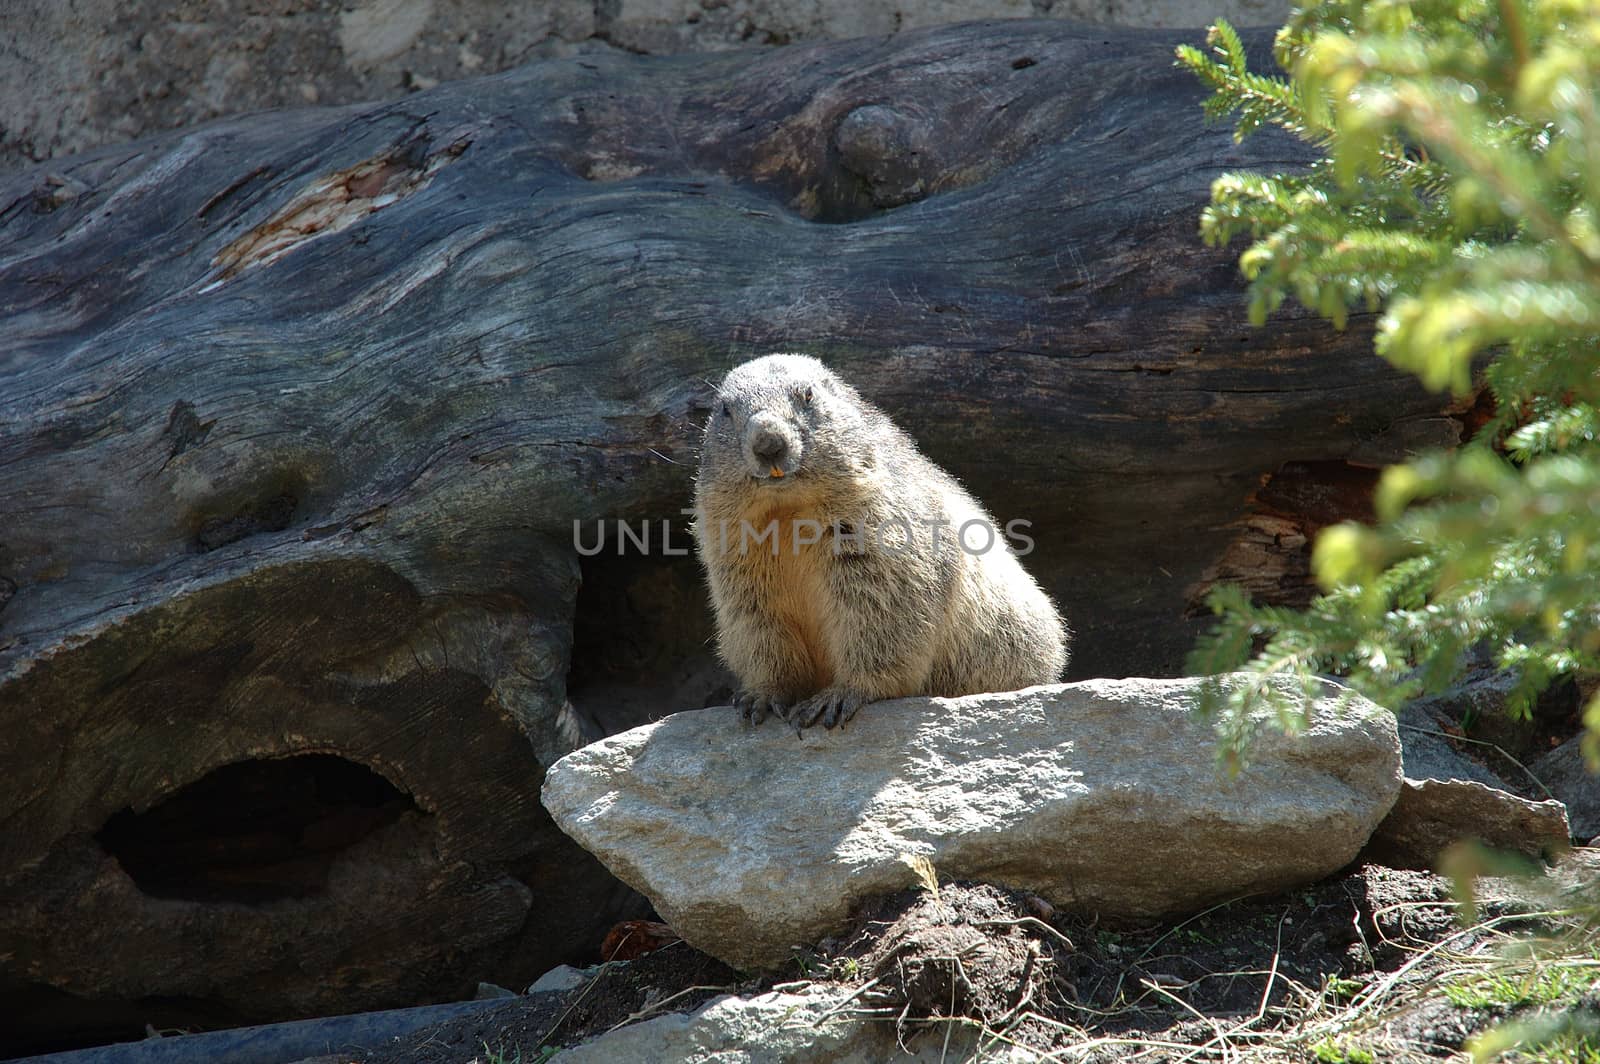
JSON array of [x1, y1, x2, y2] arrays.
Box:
[[1362, 778, 1568, 869]]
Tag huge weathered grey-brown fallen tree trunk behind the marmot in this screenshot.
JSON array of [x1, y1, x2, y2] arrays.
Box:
[[0, 21, 1458, 1049]]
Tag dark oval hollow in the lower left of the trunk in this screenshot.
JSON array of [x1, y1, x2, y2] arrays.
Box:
[[96, 754, 416, 904]]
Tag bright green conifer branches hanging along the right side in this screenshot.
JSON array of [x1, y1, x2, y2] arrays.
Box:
[[1178, 0, 1600, 765]]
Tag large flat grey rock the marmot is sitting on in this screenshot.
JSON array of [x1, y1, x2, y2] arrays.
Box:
[[544, 680, 1400, 968]]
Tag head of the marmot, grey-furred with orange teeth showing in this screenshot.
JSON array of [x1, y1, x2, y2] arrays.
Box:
[[701, 355, 870, 490]]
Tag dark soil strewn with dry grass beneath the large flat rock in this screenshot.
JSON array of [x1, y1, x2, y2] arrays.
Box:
[[347, 866, 1600, 1064]]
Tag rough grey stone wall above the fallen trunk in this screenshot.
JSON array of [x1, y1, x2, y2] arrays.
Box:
[[0, 0, 1288, 170]]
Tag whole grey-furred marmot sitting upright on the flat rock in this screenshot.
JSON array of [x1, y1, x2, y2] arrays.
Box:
[[694, 355, 1069, 730]]
